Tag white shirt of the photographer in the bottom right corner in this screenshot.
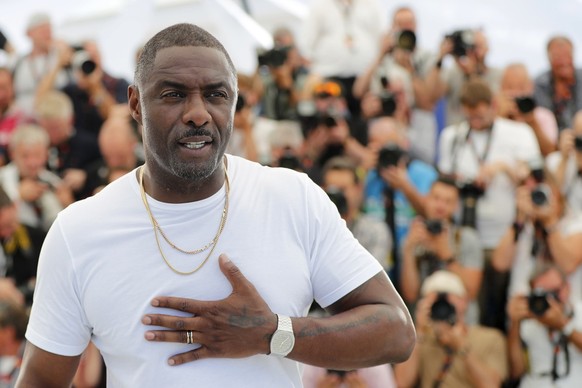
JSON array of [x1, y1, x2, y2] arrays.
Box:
[[519, 303, 582, 388]]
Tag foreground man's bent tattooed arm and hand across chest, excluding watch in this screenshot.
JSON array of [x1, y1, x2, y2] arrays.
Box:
[[143, 255, 416, 370]]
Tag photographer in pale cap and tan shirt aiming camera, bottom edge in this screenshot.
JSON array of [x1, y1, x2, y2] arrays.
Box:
[[394, 270, 508, 388]]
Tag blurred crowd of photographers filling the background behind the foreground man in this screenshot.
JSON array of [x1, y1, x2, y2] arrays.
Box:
[[0, 0, 582, 388]]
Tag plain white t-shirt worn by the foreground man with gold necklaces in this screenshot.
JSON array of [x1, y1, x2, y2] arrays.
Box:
[[26, 155, 382, 387]]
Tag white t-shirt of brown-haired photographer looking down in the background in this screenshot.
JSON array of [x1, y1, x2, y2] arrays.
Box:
[[438, 118, 541, 248]]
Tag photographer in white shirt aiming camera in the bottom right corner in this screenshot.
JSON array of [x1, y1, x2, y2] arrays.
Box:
[[507, 262, 582, 388]]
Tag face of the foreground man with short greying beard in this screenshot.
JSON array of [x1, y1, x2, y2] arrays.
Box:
[[130, 46, 237, 181]]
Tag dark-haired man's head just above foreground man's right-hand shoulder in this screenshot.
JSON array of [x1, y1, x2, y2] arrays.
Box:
[[323, 156, 362, 221]]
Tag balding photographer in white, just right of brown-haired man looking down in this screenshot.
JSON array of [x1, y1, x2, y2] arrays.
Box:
[[495, 63, 558, 156]]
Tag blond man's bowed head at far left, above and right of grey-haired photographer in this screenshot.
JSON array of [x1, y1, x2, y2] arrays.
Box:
[[35, 90, 74, 146]]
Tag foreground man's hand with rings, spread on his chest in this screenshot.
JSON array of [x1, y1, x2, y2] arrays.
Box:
[[142, 255, 277, 365]]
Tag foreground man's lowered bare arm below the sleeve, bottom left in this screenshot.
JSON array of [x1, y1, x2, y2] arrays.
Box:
[[16, 342, 81, 388]]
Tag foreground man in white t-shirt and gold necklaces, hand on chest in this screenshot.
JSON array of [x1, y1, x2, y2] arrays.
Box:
[[19, 24, 415, 387]]
